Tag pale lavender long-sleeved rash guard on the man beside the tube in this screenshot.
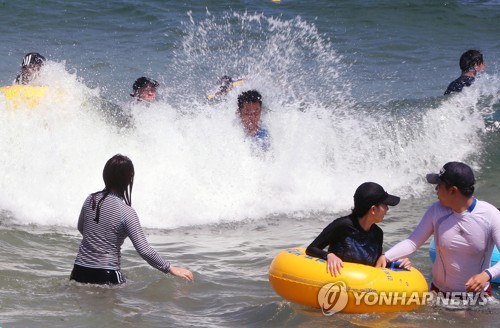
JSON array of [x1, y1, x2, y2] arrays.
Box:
[[385, 198, 500, 292]]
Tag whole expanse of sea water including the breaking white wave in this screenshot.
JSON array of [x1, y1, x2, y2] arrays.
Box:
[[0, 0, 500, 327]]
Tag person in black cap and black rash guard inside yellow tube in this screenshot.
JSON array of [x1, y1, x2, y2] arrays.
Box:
[[306, 182, 411, 276]]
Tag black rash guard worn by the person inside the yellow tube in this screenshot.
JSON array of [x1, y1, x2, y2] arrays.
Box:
[[306, 215, 384, 266]]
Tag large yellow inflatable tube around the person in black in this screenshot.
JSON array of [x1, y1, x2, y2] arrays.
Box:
[[269, 248, 428, 313]]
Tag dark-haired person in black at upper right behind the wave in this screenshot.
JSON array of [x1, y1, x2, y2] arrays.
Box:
[[444, 50, 486, 95]]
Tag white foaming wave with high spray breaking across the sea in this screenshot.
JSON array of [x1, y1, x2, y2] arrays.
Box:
[[0, 12, 498, 228]]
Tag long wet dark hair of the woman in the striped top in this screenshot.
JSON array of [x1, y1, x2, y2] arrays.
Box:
[[92, 154, 134, 223]]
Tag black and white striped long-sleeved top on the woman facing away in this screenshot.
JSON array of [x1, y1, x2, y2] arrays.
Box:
[[75, 192, 170, 273]]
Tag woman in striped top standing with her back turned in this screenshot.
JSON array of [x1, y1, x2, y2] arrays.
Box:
[[70, 154, 193, 284]]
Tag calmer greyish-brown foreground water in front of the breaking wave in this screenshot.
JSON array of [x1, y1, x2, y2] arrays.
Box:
[[0, 199, 500, 327]]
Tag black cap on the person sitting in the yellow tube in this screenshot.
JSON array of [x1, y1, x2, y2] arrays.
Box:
[[354, 182, 400, 213]]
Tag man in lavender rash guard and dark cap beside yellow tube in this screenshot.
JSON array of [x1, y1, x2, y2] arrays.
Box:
[[379, 162, 500, 295]]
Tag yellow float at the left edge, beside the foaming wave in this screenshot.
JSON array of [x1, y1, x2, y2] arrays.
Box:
[[0, 84, 49, 109]]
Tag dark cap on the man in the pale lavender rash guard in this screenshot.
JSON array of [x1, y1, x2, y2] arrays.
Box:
[[426, 162, 476, 188]]
